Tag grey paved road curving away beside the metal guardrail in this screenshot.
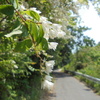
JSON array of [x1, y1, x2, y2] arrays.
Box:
[[50, 72, 100, 100]]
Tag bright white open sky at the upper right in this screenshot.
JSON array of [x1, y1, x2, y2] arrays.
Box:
[[79, 4, 100, 43]]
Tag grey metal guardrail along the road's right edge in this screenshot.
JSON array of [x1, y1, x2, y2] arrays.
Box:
[[66, 70, 100, 84]]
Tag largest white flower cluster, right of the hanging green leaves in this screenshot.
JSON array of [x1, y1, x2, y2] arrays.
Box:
[[40, 16, 66, 40]]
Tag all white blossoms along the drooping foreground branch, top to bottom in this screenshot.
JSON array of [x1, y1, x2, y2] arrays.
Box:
[[20, 5, 66, 90]]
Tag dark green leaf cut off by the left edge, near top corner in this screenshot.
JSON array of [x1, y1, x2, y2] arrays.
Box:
[[0, 5, 14, 16]]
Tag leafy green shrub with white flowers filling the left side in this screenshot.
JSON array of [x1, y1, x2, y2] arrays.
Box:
[[0, 0, 66, 100]]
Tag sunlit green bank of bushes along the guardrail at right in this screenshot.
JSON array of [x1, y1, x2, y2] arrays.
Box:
[[65, 44, 100, 94]]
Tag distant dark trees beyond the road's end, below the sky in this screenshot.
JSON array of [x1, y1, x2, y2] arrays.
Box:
[[48, 26, 95, 68]]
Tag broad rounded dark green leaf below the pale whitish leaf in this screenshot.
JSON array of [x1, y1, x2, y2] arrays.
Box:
[[15, 39, 32, 52]]
